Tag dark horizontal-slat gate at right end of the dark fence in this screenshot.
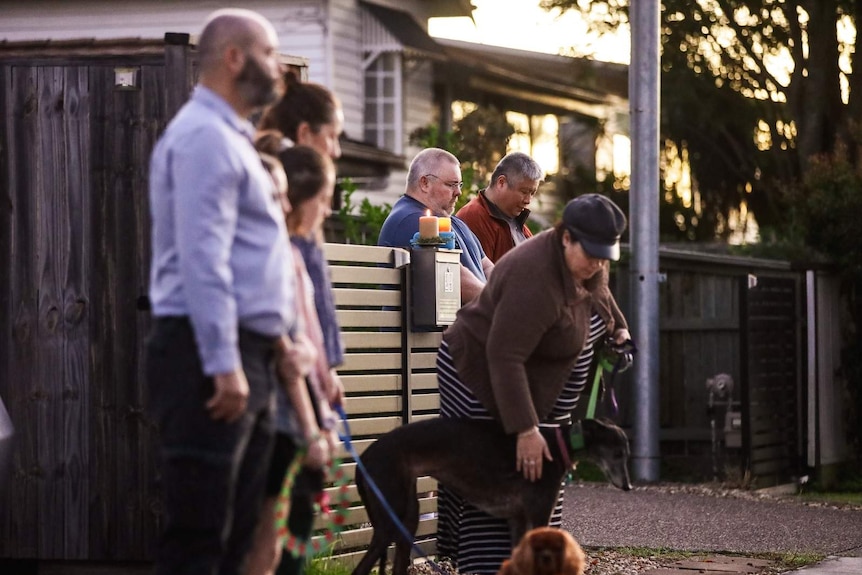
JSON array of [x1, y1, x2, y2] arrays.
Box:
[[739, 275, 804, 487]]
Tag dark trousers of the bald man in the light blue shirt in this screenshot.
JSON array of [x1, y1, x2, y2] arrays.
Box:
[[147, 317, 277, 575]]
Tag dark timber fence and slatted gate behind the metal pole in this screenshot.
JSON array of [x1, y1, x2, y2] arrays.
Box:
[[614, 248, 816, 486]]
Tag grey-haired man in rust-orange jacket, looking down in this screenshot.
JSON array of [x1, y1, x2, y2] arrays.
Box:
[[458, 152, 543, 263]]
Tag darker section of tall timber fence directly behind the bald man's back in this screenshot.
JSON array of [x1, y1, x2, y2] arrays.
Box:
[[89, 64, 170, 559]]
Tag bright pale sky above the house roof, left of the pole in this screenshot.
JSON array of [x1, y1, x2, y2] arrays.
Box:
[[428, 0, 630, 63]]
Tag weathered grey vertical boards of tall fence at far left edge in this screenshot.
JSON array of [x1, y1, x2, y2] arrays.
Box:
[[3, 62, 96, 557]]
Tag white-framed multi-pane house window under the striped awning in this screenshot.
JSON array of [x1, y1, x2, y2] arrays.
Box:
[[365, 52, 403, 154]]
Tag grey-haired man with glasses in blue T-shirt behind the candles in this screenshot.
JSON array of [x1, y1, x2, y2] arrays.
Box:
[[377, 148, 494, 303]]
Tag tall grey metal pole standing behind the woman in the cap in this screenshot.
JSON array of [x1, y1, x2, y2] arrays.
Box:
[[629, 0, 660, 482]]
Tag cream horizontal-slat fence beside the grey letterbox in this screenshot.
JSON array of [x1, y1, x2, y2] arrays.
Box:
[[318, 244, 441, 565]]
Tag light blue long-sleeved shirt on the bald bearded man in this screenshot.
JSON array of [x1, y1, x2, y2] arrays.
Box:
[[150, 85, 296, 375]]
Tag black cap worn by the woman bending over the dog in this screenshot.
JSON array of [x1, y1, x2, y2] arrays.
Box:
[[563, 194, 626, 261]]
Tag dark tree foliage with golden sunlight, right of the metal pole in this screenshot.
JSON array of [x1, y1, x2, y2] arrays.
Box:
[[542, 0, 862, 459]]
